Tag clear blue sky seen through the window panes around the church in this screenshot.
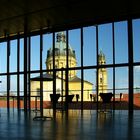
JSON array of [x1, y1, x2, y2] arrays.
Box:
[[0, 19, 140, 94]]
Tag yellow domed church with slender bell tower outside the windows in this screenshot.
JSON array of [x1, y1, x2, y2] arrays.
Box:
[[31, 32, 107, 101]]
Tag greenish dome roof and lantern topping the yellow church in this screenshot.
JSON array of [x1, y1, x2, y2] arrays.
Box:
[[47, 32, 76, 58]]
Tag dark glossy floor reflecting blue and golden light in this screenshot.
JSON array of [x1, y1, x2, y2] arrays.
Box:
[[0, 108, 140, 140]]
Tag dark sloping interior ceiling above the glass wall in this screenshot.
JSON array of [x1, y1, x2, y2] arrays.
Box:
[[0, 0, 140, 38]]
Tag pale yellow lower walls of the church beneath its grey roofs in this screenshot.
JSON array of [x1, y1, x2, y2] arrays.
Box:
[[31, 79, 92, 101]]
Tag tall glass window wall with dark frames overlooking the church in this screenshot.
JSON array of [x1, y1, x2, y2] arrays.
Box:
[[0, 19, 140, 110]]
